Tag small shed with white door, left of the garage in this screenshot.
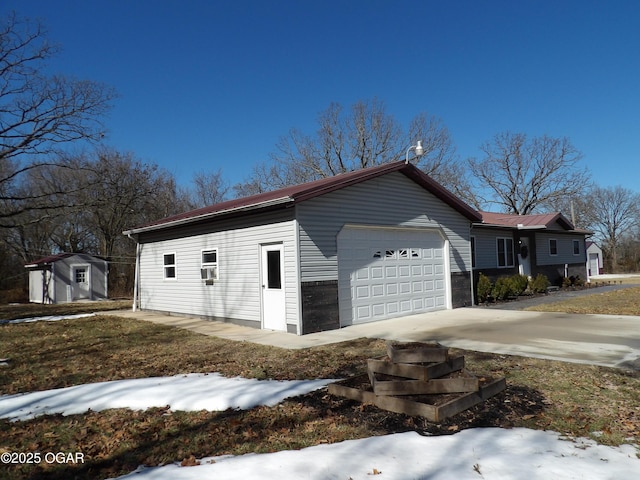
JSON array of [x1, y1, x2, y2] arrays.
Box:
[[25, 253, 108, 303]]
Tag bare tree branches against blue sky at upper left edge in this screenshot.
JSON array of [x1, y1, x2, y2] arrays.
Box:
[[0, 14, 115, 227]]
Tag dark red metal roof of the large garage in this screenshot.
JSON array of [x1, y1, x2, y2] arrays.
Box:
[[124, 161, 481, 235]]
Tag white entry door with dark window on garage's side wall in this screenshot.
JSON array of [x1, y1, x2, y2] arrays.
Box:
[[260, 243, 287, 331]]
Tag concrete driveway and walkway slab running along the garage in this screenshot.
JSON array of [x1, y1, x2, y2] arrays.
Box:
[[111, 307, 640, 370]]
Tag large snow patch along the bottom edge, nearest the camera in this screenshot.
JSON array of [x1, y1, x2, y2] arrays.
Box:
[[119, 428, 640, 480]]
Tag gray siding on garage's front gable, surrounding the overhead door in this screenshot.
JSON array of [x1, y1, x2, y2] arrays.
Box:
[[296, 173, 471, 282]]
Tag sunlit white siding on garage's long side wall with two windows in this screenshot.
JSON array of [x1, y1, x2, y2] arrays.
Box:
[[139, 212, 299, 325]]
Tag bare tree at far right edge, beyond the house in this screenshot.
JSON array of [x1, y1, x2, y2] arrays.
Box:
[[589, 186, 640, 269]]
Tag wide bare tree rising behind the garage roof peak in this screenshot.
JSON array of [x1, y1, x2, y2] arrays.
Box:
[[234, 99, 463, 195]]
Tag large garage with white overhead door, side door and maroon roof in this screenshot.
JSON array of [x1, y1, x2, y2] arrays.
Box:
[[124, 162, 480, 335]]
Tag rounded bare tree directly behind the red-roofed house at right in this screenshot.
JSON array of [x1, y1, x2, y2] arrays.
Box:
[[469, 132, 589, 215]]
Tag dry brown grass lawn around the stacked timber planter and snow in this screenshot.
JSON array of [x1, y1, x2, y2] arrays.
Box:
[[0, 300, 640, 479]]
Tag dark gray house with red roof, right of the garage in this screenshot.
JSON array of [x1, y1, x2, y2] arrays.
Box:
[[471, 212, 590, 285]]
